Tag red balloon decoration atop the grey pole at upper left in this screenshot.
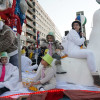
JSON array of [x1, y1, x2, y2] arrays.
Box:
[[0, 0, 22, 34]]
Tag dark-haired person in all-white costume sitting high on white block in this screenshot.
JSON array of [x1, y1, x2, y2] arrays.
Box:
[[67, 21, 96, 73]]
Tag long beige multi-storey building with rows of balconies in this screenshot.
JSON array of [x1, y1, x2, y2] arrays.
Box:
[[21, 0, 61, 46]]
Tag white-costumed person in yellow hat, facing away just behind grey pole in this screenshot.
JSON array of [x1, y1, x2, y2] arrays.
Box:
[[21, 49, 38, 72]]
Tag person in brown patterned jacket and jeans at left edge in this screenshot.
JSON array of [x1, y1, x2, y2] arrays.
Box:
[[0, 17, 18, 67]]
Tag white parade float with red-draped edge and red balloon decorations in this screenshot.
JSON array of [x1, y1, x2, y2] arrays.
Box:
[[0, 0, 100, 100]]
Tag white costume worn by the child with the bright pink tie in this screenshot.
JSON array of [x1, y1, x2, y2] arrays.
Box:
[[0, 63, 20, 91]]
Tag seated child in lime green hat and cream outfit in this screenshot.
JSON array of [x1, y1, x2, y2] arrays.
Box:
[[31, 54, 56, 91]]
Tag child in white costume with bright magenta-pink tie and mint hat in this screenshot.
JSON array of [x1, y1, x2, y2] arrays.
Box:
[[0, 52, 19, 95]]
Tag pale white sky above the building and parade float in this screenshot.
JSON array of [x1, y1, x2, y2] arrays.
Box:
[[38, 0, 100, 39]]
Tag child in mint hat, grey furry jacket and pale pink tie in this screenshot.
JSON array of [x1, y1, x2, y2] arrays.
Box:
[[41, 32, 66, 74]]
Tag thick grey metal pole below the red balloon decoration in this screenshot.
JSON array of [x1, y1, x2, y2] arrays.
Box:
[[17, 34, 22, 82]]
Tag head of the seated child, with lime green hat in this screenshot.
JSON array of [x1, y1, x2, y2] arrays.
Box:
[[41, 54, 53, 67]]
